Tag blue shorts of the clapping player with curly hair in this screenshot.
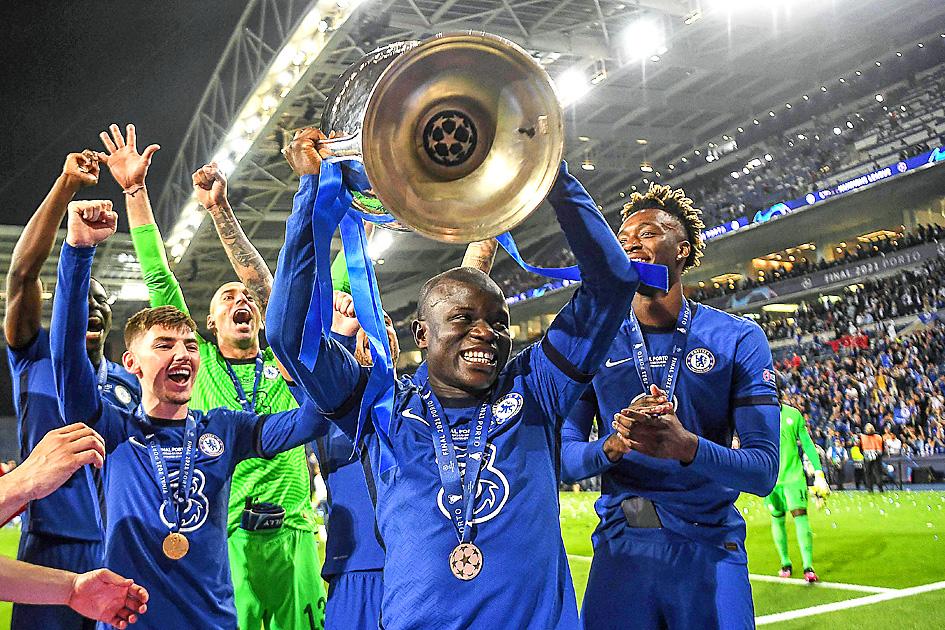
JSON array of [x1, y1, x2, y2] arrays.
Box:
[[581, 529, 755, 630]]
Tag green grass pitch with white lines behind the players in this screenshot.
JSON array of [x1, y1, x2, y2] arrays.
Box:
[[0, 491, 945, 630]]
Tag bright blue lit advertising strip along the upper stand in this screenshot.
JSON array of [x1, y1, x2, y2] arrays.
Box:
[[702, 147, 945, 241]]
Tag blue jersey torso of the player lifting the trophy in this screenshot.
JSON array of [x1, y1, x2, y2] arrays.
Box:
[[329, 346, 586, 629]]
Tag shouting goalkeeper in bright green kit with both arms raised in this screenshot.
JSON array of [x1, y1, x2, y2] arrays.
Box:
[[101, 125, 326, 630]]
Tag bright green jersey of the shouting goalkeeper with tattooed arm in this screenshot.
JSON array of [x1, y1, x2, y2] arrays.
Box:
[[131, 224, 317, 534]]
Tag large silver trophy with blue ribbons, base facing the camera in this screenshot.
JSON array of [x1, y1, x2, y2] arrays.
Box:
[[321, 32, 564, 243]]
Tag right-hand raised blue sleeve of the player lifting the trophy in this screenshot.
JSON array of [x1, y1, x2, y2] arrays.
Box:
[[528, 162, 639, 418]]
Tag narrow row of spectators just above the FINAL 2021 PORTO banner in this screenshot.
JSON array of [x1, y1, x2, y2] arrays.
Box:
[[691, 224, 945, 301]]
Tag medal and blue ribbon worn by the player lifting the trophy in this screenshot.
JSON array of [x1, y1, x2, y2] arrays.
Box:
[[421, 387, 492, 581]]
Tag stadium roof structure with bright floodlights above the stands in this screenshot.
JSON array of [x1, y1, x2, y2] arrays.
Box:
[[4, 0, 945, 326]]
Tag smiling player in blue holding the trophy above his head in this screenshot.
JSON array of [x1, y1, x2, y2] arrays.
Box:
[[267, 130, 638, 630]]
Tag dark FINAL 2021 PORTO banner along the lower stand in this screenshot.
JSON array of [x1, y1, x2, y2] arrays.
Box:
[[705, 241, 945, 309]]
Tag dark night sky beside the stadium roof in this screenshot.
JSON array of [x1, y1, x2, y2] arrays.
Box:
[[0, 0, 245, 225]]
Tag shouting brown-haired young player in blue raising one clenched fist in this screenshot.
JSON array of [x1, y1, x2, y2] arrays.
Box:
[[50, 202, 342, 629]]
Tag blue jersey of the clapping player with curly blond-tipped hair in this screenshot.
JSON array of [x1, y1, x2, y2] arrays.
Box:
[[563, 304, 778, 545]]
